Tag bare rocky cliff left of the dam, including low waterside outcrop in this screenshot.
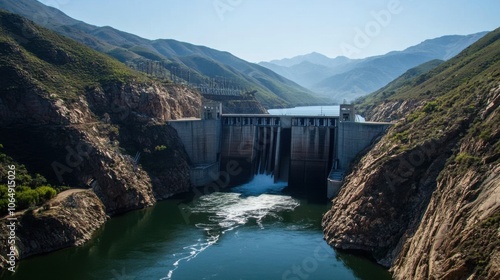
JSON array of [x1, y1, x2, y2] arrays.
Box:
[[0, 83, 201, 258]]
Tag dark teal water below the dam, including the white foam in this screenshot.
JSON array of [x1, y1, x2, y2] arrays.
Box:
[[2, 175, 391, 280]]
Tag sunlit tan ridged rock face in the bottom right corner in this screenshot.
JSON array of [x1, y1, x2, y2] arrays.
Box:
[[393, 86, 500, 279]]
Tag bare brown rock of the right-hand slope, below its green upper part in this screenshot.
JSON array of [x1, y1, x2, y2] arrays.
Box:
[[323, 86, 500, 279]]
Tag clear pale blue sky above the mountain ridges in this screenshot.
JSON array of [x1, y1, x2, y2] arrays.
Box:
[[39, 0, 500, 62]]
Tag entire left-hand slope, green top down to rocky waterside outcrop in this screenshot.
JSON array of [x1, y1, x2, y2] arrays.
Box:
[[0, 11, 201, 264]]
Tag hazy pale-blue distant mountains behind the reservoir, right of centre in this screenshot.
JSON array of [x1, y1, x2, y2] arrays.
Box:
[[260, 32, 486, 102]]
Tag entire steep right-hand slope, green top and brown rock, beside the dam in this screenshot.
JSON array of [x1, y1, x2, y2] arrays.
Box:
[[323, 27, 500, 279]]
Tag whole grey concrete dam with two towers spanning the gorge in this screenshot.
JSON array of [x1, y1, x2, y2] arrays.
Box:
[[168, 103, 391, 198]]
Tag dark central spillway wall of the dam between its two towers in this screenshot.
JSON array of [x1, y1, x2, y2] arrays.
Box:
[[221, 115, 338, 189]]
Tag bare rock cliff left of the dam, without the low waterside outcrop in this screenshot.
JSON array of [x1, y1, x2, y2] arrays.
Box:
[[0, 83, 201, 215]]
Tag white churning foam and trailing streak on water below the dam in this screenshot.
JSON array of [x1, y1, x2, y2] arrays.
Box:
[[163, 174, 299, 280]]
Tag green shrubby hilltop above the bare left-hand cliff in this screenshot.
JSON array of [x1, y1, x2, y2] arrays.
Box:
[[0, 11, 146, 100]]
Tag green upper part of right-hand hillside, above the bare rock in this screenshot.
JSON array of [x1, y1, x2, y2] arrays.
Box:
[[359, 28, 500, 152]]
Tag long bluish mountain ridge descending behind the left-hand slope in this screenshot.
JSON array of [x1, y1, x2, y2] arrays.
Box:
[[0, 0, 327, 107]]
